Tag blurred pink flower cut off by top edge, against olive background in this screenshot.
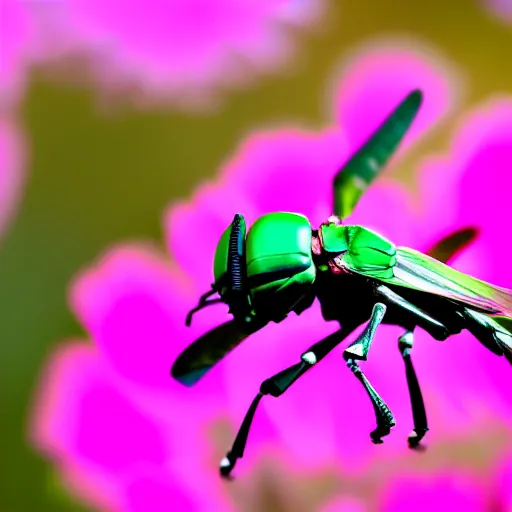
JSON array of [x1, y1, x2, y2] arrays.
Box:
[[31, 0, 323, 105]]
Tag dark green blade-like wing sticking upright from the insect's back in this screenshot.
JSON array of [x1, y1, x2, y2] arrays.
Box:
[[333, 90, 423, 219]]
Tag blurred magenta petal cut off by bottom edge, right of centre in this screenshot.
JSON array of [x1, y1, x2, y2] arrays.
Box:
[[379, 470, 486, 512]]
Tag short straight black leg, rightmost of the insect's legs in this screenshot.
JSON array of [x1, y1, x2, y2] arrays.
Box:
[[398, 331, 429, 448]]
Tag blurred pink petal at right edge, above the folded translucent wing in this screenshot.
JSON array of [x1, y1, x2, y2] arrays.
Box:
[[420, 98, 512, 266]]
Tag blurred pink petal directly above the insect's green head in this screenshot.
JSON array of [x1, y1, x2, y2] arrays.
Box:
[[223, 128, 347, 223]]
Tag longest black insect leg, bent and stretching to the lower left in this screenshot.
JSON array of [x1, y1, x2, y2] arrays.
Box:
[[220, 325, 357, 476]]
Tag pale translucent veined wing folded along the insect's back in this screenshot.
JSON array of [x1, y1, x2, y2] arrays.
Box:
[[382, 247, 512, 317]]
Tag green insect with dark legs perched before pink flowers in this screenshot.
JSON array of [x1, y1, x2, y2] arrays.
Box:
[[171, 90, 512, 476]]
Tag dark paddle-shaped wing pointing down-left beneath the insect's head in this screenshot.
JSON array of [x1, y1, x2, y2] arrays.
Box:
[[171, 320, 249, 386]]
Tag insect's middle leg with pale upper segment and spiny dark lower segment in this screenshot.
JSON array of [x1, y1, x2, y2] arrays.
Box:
[[343, 303, 395, 444]]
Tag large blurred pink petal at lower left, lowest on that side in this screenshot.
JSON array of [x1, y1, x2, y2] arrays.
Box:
[[31, 342, 224, 510]]
